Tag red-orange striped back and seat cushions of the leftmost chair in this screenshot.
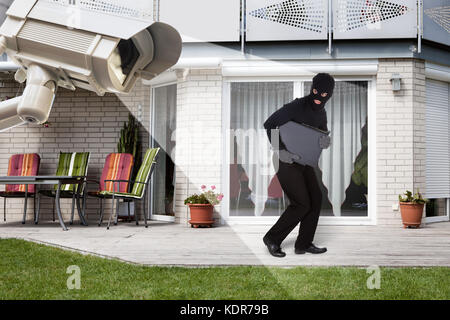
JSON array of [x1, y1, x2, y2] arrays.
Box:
[[5, 153, 41, 193]]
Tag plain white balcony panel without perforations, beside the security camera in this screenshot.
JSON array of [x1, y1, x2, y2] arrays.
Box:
[[160, 0, 240, 42]]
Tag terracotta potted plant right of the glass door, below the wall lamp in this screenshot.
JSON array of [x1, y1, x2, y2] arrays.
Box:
[[398, 190, 428, 228]]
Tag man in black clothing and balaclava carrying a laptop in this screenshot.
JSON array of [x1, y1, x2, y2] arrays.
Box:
[[263, 73, 334, 257]]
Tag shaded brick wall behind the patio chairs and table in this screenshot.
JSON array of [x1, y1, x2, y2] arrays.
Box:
[[0, 74, 150, 221]]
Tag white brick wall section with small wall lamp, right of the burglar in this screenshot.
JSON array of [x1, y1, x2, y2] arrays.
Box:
[[376, 59, 425, 225]]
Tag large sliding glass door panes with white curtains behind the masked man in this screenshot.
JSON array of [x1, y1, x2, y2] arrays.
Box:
[[228, 81, 369, 217]]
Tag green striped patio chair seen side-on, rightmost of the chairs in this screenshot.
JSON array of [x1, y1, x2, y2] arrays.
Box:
[[100, 148, 160, 230]]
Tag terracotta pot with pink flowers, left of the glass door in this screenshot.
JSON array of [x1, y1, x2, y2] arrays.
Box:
[[184, 185, 223, 228]]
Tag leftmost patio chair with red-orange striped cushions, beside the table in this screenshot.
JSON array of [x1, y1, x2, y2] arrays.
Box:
[[0, 153, 41, 223]]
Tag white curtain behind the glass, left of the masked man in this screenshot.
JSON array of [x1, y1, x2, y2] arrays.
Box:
[[230, 82, 293, 216]]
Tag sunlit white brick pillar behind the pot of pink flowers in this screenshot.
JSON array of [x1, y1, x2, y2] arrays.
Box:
[[175, 69, 223, 224]]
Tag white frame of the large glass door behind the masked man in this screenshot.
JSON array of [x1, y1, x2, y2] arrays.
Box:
[[221, 76, 377, 225]]
